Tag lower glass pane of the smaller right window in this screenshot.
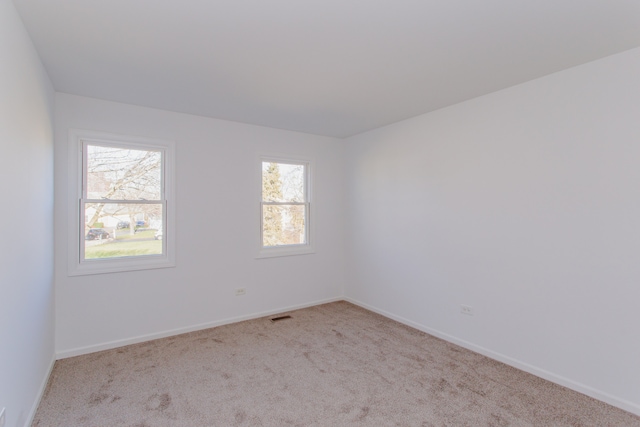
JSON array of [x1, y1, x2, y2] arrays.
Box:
[[262, 205, 307, 246]]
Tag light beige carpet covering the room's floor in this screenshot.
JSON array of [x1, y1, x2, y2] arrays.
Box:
[[33, 302, 640, 427]]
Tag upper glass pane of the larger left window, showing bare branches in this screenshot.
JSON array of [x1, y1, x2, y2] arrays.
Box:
[[86, 145, 162, 200]]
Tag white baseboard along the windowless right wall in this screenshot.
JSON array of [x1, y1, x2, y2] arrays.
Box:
[[344, 297, 640, 415]]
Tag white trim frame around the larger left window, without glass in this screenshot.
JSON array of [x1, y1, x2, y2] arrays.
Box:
[[67, 129, 176, 276]]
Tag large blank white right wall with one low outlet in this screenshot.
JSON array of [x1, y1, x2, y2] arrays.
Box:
[[346, 49, 640, 414]]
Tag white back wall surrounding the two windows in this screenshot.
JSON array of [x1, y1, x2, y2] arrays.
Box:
[[55, 94, 344, 356]]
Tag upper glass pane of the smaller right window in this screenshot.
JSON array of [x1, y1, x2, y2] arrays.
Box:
[[262, 162, 305, 203]]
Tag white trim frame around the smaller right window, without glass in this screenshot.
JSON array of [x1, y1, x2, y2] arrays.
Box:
[[256, 154, 316, 259]]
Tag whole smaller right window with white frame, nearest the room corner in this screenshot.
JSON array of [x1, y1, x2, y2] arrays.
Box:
[[260, 158, 313, 257]]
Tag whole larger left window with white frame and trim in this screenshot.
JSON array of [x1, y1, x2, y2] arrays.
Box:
[[69, 131, 175, 275]]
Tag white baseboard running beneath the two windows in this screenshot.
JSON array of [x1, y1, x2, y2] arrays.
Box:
[[56, 297, 344, 359]]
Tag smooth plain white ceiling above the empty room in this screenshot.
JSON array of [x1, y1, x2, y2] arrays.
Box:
[[14, 0, 640, 137]]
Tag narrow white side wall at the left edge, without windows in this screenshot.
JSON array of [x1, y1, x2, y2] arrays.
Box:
[[0, 0, 54, 427]]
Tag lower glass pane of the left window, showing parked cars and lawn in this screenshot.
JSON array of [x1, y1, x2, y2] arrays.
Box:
[[84, 203, 164, 259]]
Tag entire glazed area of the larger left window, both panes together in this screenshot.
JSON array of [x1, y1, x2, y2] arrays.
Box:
[[83, 143, 164, 259]]
